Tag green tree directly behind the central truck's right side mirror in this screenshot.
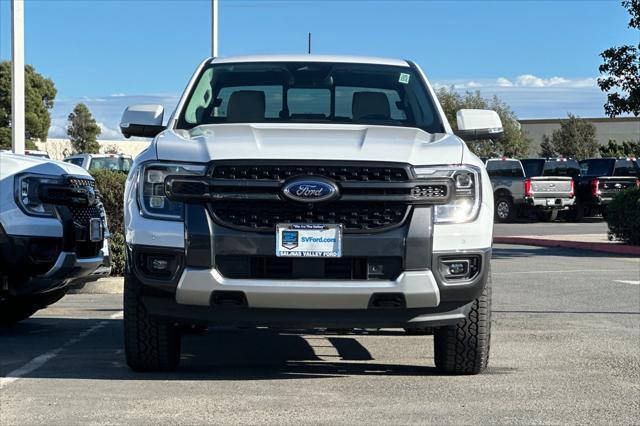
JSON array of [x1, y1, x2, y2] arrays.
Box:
[[437, 88, 531, 157]]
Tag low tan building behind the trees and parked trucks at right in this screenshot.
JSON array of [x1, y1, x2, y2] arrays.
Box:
[[519, 117, 640, 155]]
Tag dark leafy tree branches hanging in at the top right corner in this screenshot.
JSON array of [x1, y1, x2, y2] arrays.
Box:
[[598, 0, 640, 117]]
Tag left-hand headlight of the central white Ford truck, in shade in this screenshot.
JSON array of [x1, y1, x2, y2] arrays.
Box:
[[138, 163, 206, 220]]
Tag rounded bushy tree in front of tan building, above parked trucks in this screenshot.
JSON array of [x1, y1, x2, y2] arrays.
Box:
[[540, 114, 599, 160]]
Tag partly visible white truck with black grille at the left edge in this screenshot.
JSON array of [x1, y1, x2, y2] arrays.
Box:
[[0, 153, 109, 324]]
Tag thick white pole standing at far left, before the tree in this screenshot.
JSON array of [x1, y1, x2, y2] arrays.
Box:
[[11, 0, 24, 154]]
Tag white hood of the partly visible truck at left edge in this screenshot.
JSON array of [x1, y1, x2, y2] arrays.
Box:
[[0, 153, 91, 179]]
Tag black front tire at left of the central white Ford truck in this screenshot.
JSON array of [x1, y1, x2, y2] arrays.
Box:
[[123, 270, 180, 371]]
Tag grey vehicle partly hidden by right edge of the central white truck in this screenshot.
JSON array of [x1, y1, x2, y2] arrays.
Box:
[[485, 157, 526, 222]]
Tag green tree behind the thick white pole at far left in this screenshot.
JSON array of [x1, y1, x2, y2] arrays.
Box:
[[0, 61, 57, 149]]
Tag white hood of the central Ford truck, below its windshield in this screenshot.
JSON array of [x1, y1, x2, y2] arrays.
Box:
[[156, 123, 464, 165]]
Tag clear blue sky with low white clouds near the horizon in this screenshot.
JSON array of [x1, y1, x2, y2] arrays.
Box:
[[0, 0, 640, 139]]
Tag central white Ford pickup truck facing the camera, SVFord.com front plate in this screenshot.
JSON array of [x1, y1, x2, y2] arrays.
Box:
[[121, 55, 502, 374]]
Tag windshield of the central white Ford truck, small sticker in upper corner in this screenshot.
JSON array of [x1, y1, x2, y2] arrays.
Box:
[[178, 62, 444, 133]]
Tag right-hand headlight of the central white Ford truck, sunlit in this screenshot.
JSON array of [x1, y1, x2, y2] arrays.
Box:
[[414, 165, 482, 223]]
